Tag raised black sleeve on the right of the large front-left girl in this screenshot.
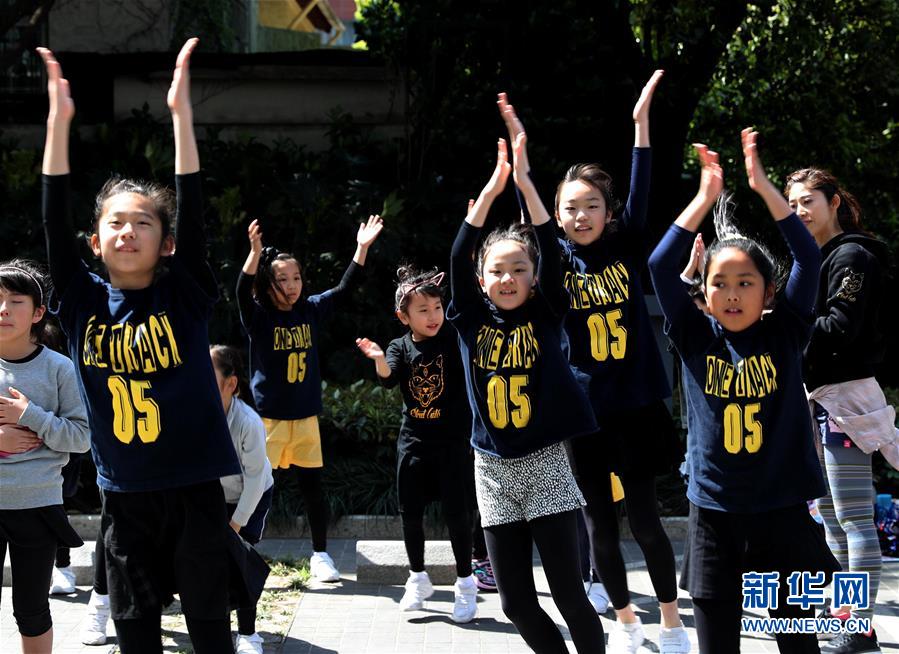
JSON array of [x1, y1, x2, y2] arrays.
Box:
[[174, 172, 218, 298]]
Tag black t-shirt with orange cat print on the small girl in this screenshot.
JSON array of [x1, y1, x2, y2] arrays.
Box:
[[381, 325, 471, 451]]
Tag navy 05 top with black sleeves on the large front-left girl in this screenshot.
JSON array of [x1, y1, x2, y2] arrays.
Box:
[[43, 173, 240, 492]]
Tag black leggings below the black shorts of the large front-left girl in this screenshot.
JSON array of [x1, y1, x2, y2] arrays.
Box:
[[114, 615, 234, 654]]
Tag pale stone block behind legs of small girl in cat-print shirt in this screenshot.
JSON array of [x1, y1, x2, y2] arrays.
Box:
[[356, 540, 457, 585]]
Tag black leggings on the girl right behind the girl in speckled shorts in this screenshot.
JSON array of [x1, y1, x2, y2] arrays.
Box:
[[577, 460, 677, 610]]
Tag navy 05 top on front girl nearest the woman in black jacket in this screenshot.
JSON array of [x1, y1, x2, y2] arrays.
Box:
[[649, 214, 824, 513]]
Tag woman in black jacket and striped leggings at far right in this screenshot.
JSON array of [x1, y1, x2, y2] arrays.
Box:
[[786, 168, 897, 654]]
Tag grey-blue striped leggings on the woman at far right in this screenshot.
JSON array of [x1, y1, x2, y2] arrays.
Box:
[[818, 410, 881, 618]]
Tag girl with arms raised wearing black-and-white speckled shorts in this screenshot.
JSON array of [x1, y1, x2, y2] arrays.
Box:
[[447, 96, 605, 654]]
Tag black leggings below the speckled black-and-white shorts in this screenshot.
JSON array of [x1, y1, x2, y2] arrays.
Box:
[[484, 511, 606, 654]]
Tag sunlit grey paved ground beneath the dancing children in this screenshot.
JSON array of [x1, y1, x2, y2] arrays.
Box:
[[0, 540, 899, 654]]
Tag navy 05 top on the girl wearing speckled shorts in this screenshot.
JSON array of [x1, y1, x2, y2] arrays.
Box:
[[447, 223, 596, 458]]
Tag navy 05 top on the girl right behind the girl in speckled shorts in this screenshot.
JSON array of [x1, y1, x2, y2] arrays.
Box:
[[560, 148, 671, 420]]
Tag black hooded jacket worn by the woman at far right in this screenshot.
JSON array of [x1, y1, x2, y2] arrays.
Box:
[[804, 232, 895, 391]]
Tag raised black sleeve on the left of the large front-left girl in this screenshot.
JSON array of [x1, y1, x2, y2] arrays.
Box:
[[41, 175, 81, 297]]
